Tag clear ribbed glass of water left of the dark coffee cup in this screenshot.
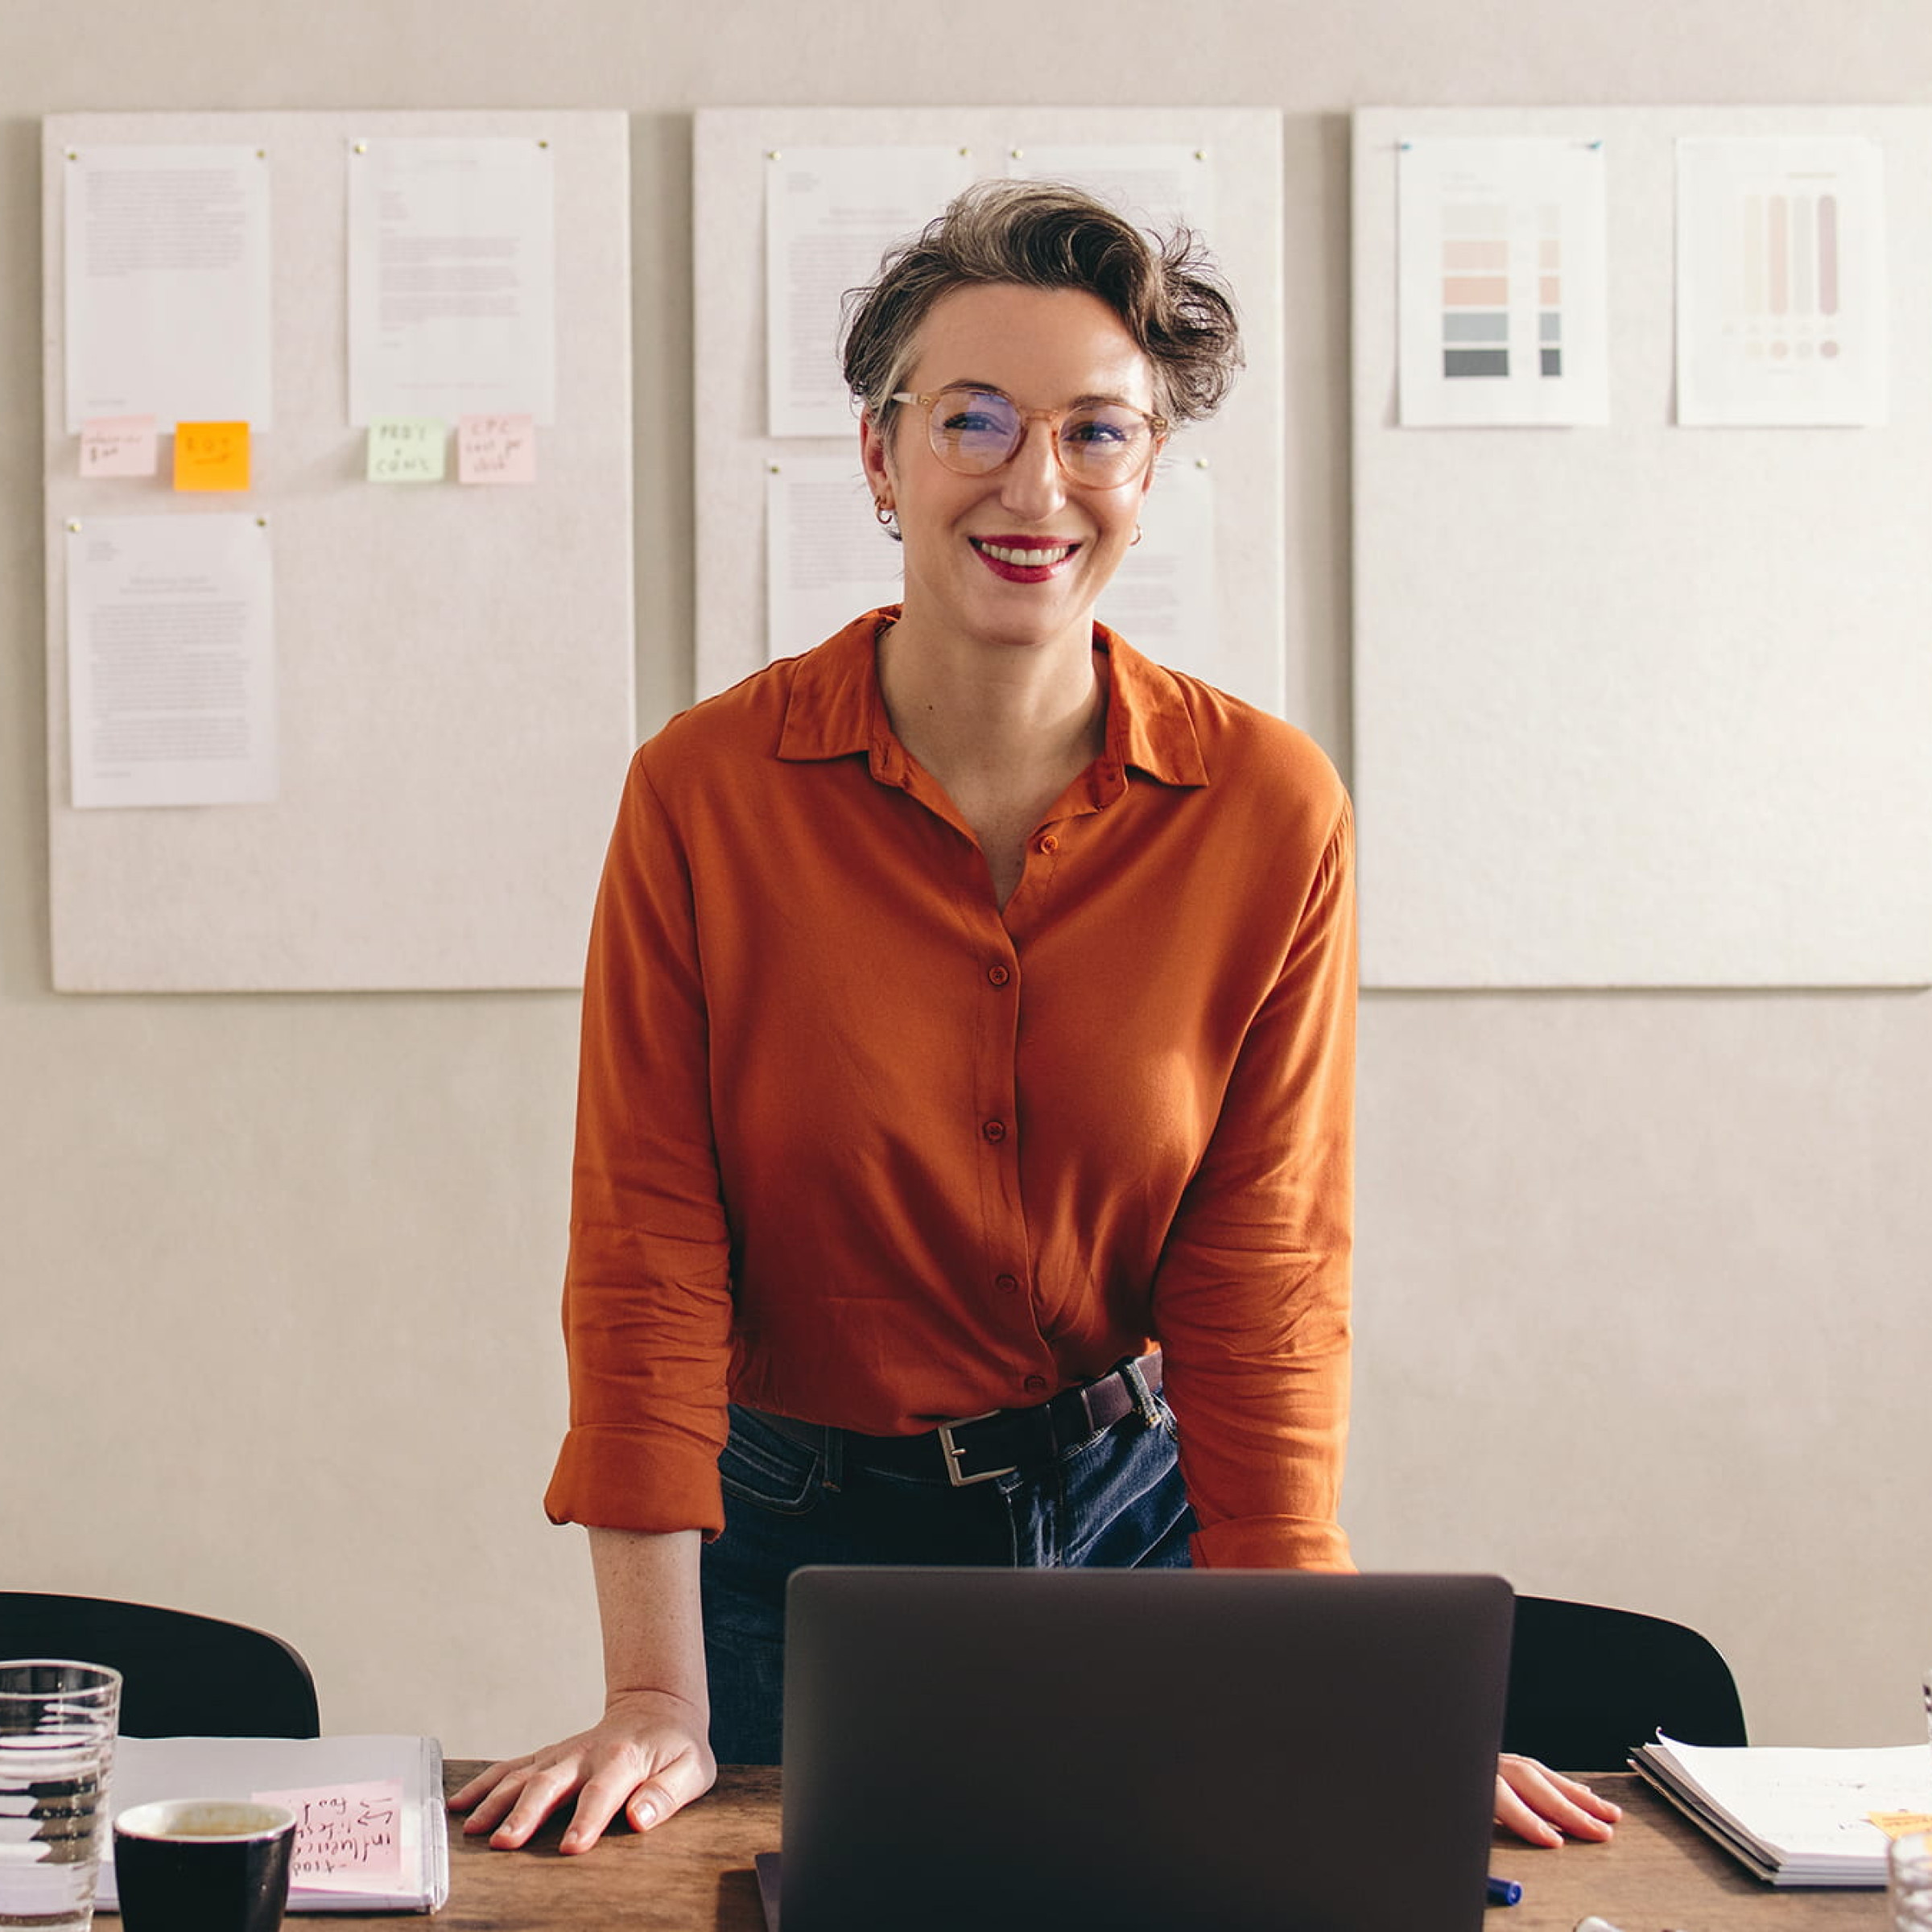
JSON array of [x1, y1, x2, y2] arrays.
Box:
[[0, 1657, 120, 1932]]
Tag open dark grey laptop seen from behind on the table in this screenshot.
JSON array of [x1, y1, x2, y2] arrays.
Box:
[[759, 1569, 1513, 1932]]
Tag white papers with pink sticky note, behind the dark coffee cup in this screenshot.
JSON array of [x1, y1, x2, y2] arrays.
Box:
[[95, 1737, 450, 1913]]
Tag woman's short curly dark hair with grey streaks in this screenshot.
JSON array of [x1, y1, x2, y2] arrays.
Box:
[[844, 180, 1241, 431]]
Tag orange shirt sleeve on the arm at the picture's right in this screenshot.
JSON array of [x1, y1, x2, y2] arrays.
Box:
[[1154, 798, 1356, 1571]]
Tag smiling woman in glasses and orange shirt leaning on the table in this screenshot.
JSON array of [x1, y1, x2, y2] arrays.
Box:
[[456, 184, 1615, 1851]]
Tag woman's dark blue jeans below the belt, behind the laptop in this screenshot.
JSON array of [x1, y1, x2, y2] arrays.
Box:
[[704, 1397, 1194, 1764]]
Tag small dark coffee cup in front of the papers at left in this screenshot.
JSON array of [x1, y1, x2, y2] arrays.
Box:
[[114, 1798, 295, 1932]]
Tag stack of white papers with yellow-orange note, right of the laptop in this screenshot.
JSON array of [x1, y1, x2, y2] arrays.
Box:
[[1631, 1731, 1932, 1885]]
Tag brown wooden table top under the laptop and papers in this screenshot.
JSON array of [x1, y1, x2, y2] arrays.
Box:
[[215, 1764, 1889, 1932]]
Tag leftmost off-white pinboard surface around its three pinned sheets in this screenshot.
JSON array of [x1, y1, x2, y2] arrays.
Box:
[[43, 112, 636, 993]]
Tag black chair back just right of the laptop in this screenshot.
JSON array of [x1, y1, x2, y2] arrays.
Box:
[[1503, 1596, 1747, 1772]]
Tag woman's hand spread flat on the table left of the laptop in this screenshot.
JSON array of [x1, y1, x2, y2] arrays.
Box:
[[450, 1690, 719, 1853]]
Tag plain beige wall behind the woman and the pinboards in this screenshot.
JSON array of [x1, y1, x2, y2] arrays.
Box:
[[0, 0, 1932, 1754]]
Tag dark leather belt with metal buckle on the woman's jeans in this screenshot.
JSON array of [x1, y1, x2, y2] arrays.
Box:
[[752, 1348, 1161, 1489]]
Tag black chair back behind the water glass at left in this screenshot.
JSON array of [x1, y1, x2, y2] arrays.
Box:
[[0, 1590, 320, 1737]]
